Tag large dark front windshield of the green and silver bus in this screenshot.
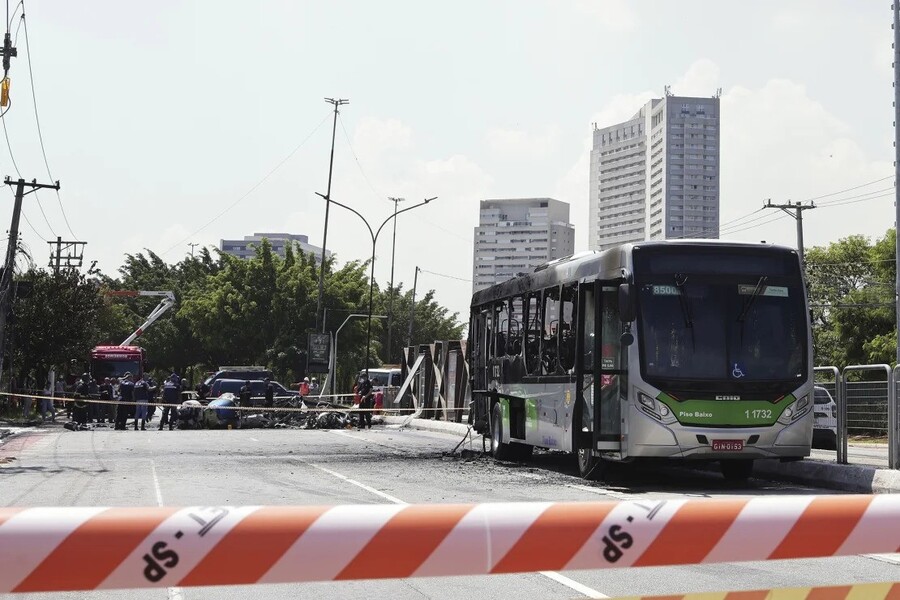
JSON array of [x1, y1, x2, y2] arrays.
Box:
[[638, 282, 807, 383]]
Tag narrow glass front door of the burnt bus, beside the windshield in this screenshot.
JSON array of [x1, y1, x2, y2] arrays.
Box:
[[593, 281, 628, 451]]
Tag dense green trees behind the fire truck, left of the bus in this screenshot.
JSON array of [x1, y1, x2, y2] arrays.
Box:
[[7, 240, 463, 390]]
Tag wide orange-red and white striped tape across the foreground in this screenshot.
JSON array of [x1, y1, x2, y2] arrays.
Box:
[[0, 494, 900, 593]]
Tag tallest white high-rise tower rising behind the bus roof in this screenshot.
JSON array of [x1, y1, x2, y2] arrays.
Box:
[[588, 96, 720, 250]]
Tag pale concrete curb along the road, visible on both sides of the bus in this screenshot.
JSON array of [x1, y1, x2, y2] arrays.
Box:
[[384, 417, 900, 494]]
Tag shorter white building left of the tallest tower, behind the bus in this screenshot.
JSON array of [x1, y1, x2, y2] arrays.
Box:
[[472, 198, 575, 292]]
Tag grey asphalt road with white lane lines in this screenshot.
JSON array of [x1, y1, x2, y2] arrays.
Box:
[[0, 428, 900, 600]]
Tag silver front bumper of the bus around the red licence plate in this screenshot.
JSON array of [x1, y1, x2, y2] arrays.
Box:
[[626, 406, 812, 460]]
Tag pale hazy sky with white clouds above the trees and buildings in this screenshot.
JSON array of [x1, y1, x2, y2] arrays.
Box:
[[0, 0, 894, 328]]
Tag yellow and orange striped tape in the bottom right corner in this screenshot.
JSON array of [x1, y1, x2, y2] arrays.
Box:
[[613, 582, 900, 600]]
